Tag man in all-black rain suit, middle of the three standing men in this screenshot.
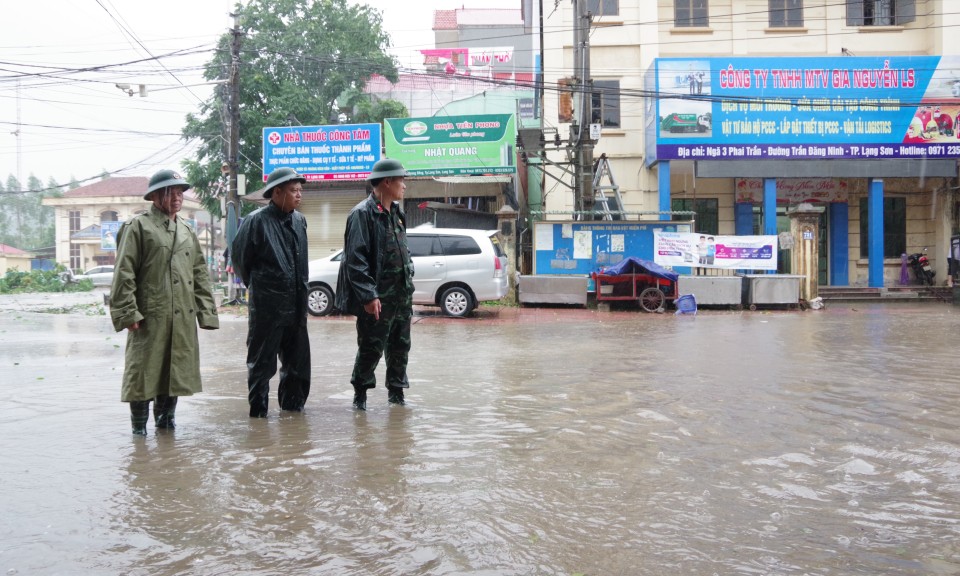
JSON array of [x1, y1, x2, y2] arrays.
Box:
[[231, 168, 310, 418]]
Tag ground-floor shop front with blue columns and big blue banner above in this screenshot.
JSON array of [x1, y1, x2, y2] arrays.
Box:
[[646, 56, 960, 287]]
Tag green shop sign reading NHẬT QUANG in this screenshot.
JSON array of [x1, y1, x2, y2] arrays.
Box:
[[384, 114, 517, 176]]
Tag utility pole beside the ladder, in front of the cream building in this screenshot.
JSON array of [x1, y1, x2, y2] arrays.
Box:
[[570, 0, 593, 219]]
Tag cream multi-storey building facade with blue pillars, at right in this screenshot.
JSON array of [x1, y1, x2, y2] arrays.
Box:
[[543, 0, 960, 286]]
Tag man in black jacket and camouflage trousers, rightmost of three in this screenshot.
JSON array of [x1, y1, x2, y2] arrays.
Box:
[[336, 158, 413, 410]]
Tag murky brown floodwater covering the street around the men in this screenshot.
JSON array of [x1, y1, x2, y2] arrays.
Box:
[[0, 303, 960, 576]]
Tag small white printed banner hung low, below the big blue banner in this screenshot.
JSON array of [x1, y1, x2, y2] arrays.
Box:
[[653, 230, 777, 270]]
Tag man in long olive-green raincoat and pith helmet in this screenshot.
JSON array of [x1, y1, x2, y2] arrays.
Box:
[[110, 170, 220, 435]]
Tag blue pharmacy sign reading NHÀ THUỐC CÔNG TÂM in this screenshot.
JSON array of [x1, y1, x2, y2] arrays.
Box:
[[263, 124, 381, 182]]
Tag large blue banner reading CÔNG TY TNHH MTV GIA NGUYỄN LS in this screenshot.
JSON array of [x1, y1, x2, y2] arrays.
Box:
[[648, 56, 960, 160]]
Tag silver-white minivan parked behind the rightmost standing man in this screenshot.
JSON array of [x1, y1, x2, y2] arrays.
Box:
[[307, 226, 508, 316]]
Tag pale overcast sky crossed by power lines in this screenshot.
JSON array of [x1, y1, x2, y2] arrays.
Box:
[[0, 0, 520, 186]]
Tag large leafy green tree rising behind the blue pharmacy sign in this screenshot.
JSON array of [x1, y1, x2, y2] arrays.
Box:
[[182, 0, 397, 214]]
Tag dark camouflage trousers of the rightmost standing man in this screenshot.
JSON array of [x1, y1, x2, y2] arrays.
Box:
[[350, 296, 413, 389]]
